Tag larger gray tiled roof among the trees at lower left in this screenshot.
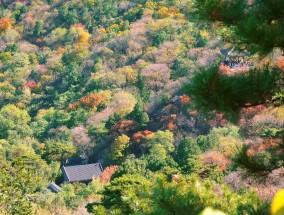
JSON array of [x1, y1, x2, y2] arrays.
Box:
[[62, 163, 103, 182]]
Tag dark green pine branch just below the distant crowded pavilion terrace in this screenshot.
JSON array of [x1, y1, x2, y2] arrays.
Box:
[[185, 65, 281, 113]]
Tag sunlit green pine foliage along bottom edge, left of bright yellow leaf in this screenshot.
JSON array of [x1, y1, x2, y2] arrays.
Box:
[[149, 175, 269, 215]]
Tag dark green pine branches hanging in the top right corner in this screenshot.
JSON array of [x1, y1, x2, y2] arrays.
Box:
[[194, 0, 284, 51]]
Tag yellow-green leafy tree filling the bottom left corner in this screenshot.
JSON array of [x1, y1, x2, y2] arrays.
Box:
[[0, 148, 49, 215]]
